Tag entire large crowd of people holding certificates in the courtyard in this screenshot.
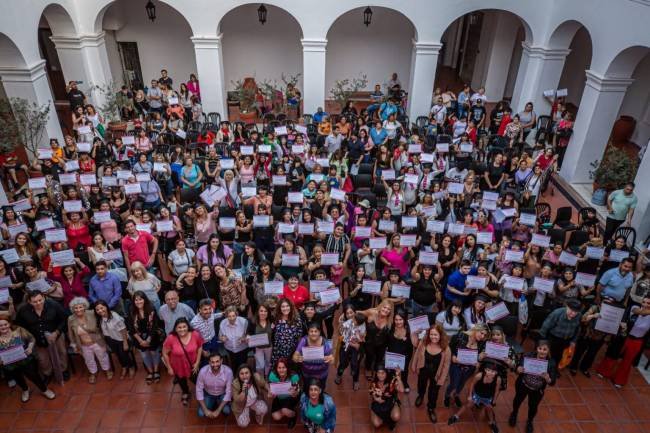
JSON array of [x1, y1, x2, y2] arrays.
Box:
[[0, 67, 650, 433]]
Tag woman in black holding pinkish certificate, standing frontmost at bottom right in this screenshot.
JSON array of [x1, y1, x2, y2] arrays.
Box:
[[508, 340, 557, 433]]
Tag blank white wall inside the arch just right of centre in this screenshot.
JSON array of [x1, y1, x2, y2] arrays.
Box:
[[325, 7, 410, 94]]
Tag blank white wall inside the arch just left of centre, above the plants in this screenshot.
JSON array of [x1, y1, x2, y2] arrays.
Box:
[[220, 4, 302, 90]]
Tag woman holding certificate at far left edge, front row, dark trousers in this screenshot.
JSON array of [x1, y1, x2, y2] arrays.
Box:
[[0, 319, 56, 403]]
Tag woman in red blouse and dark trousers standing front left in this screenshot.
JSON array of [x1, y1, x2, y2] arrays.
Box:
[[162, 317, 204, 406]]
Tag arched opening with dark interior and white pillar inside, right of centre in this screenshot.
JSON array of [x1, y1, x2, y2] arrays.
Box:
[[435, 9, 532, 102]]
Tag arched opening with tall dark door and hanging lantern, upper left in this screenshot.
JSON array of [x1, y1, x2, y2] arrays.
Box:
[[95, 0, 196, 90]]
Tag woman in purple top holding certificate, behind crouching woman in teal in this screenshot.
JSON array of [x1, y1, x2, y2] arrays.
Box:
[[292, 323, 334, 389]]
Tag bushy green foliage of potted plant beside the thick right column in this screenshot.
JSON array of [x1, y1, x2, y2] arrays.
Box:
[[589, 147, 639, 191]]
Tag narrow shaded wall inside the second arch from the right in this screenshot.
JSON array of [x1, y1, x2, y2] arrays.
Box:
[[558, 27, 591, 106]]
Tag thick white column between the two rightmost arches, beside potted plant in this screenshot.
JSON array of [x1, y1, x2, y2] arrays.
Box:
[[560, 71, 634, 183]]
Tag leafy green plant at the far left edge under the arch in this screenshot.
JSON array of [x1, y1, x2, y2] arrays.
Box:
[[0, 98, 50, 155]]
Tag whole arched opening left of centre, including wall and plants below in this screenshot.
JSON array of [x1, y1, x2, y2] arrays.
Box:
[[219, 4, 303, 119]]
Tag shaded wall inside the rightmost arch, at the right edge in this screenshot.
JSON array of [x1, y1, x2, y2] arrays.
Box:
[[619, 54, 650, 146]]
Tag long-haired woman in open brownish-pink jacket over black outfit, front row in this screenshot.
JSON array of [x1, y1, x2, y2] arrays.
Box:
[[410, 324, 451, 424]]
